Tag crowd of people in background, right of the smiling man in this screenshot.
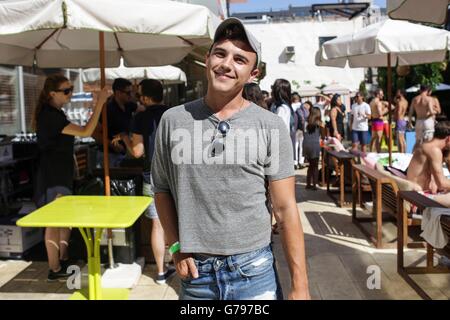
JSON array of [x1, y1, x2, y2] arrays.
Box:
[[243, 75, 448, 200]]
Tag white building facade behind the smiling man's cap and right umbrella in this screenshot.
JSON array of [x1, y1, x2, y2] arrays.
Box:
[[232, 6, 382, 91]]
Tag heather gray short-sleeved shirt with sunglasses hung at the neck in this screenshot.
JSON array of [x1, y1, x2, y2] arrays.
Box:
[[152, 99, 294, 255]]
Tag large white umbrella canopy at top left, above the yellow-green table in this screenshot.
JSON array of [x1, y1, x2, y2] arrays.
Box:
[[0, 0, 220, 68]]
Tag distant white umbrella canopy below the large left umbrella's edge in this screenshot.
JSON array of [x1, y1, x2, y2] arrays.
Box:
[[82, 66, 187, 83]]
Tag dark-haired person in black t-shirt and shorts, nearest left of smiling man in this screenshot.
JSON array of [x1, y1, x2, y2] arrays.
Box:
[[131, 79, 175, 284]]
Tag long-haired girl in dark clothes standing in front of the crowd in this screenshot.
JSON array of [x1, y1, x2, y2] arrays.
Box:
[[303, 107, 325, 190]]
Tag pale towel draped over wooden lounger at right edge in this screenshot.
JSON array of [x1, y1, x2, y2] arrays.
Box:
[[420, 208, 450, 249]]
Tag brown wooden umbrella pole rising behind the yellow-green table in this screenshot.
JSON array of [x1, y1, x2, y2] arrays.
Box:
[[99, 32, 115, 268]]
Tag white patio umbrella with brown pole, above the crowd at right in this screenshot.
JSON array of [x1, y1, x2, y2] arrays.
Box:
[[316, 19, 449, 165]]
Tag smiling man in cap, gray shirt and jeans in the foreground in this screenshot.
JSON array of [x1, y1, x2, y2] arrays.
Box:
[[152, 18, 309, 300]]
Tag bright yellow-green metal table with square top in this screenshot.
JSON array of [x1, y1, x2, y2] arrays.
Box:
[[17, 196, 153, 300]]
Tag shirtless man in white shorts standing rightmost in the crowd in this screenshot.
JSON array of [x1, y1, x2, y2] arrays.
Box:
[[408, 85, 439, 148]]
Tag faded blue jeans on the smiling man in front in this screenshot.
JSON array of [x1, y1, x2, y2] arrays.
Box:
[[180, 245, 283, 300]]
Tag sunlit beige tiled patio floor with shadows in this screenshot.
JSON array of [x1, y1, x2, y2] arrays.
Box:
[[0, 169, 450, 300]]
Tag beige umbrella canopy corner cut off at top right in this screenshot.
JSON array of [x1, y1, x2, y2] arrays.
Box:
[[387, 0, 449, 24]]
